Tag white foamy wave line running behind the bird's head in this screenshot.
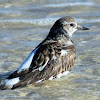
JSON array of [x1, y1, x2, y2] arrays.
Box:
[[0, 18, 100, 26]]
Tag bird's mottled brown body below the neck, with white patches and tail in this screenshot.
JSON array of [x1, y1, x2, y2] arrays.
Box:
[[2, 41, 75, 89]]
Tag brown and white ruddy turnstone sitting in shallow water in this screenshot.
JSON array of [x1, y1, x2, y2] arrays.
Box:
[[0, 16, 88, 90]]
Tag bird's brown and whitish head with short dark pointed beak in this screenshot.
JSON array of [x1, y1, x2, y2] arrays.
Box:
[[49, 16, 89, 37]]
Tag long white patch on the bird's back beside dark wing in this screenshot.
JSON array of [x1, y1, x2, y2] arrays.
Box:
[[17, 48, 38, 73]]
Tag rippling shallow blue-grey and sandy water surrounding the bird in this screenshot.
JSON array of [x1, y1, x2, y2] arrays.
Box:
[[0, 0, 100, 100]]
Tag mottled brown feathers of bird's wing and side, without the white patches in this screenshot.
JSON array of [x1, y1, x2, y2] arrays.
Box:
[[12, 38, 76, 89]]
